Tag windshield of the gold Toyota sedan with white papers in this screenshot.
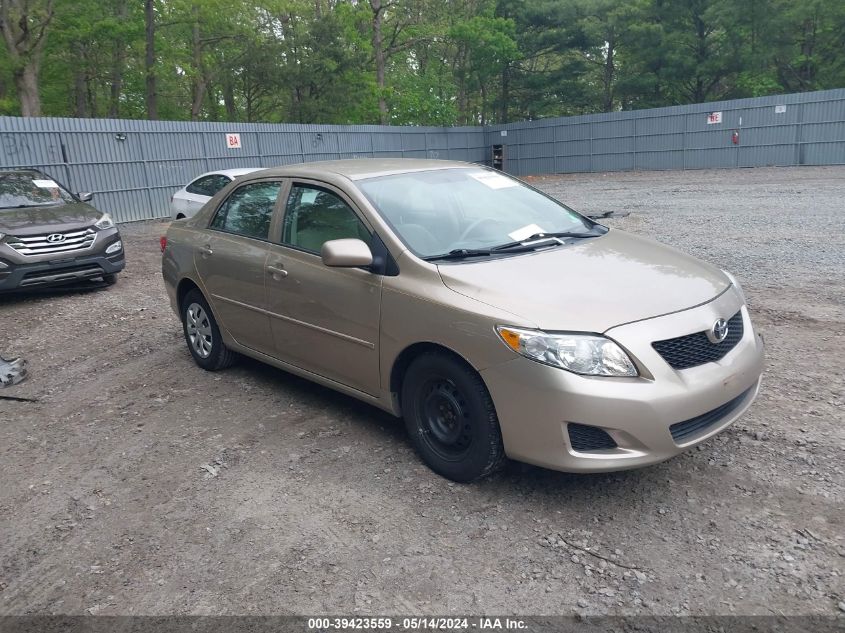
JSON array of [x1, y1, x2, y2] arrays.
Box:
[[356, 167, 595, 258]]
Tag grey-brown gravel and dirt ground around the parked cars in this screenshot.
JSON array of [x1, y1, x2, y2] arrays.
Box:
[[0, 167, 845, 615]]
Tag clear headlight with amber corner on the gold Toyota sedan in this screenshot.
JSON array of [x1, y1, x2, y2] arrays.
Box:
[[496, 325, 638, 376]]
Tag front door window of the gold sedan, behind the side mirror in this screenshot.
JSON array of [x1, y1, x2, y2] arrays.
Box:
[[282, 185, 371, 253]]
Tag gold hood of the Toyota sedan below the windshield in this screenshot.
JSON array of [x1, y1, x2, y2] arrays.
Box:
[[438, 229, 731, 332]]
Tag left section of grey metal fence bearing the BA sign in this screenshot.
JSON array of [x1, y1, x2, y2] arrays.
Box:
[[0, 117, 487, 222]]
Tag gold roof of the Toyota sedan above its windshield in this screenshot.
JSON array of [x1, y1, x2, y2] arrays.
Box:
[[244, 158, 480, 180]]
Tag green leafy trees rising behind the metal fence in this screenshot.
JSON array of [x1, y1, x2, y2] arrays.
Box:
[[0, 0, 845, 126]]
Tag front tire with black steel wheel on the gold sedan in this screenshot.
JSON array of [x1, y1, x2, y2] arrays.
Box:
[[401, 352, 506, 483]]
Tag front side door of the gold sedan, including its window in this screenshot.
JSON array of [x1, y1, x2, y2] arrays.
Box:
[[266, 183, 382, 395]]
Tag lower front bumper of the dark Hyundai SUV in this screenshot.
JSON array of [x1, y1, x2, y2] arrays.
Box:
[[0, 249, 126, 292]]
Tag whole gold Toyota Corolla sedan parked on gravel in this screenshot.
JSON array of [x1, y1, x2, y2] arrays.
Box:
[[162, 159, 763, 482]]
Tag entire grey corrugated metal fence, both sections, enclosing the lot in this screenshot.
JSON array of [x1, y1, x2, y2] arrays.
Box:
[[0, 89, 845, 222]]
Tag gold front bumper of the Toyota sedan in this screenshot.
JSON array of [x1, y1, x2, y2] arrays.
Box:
[[481, 290, 763, 472]]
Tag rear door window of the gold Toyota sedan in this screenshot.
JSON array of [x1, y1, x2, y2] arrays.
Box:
[[211, 182, 282, 240]]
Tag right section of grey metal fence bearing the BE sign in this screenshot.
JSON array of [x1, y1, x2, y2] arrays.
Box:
[[486, 89, 845, 175]]
